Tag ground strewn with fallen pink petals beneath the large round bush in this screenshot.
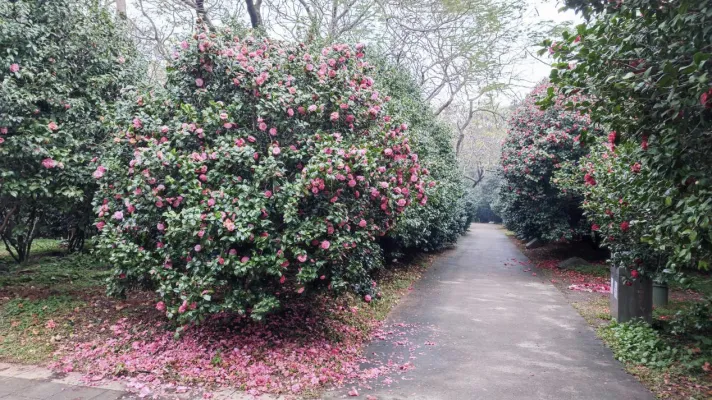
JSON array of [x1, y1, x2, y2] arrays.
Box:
[[46, 260, 434, 398]]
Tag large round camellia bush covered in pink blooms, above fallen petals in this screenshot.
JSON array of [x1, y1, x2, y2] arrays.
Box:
[[94, 29, 429, 323]]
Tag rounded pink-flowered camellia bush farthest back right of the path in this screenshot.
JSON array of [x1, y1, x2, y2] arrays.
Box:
[[498, 83, 594, 241]]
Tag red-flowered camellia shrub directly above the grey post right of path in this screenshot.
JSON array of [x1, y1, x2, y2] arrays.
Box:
[[556, 141, 671, 279]]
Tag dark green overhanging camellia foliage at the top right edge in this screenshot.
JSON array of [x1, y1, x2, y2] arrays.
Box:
[[543, 0, 712, 270]]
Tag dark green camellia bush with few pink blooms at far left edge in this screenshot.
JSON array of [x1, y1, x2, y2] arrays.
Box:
[[0, 0, 141, 262]]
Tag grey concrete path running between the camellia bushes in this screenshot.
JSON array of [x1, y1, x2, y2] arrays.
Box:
[[327, 224, 654, 400]]
